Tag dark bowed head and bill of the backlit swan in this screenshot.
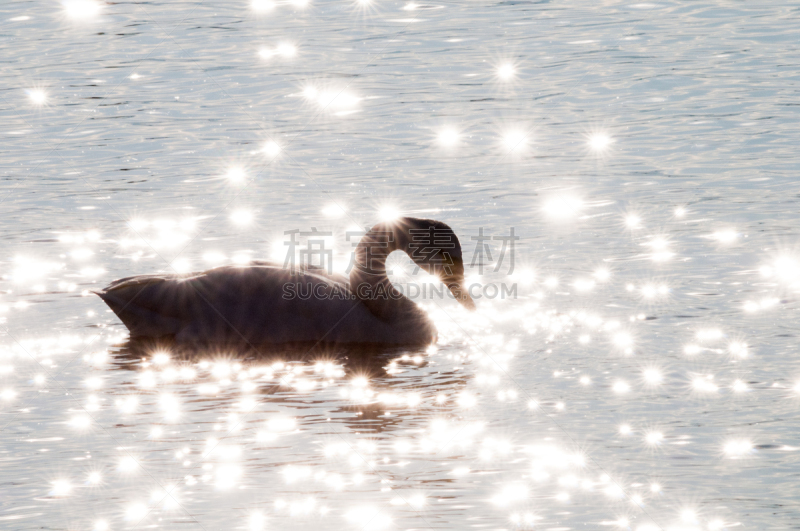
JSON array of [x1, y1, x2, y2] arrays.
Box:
[[396, 218, 475, 310]]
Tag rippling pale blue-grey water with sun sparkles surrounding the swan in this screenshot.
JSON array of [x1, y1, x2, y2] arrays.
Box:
[[0, 0, 800, 531]]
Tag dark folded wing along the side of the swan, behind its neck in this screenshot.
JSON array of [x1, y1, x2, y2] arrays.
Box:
[[96, 262, 373, 343]]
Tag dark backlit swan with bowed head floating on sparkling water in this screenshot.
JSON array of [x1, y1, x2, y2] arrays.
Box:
[[95, 217, 475, 346]]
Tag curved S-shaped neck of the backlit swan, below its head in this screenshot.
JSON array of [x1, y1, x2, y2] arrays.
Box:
[[350, 223, 416, 320]]
